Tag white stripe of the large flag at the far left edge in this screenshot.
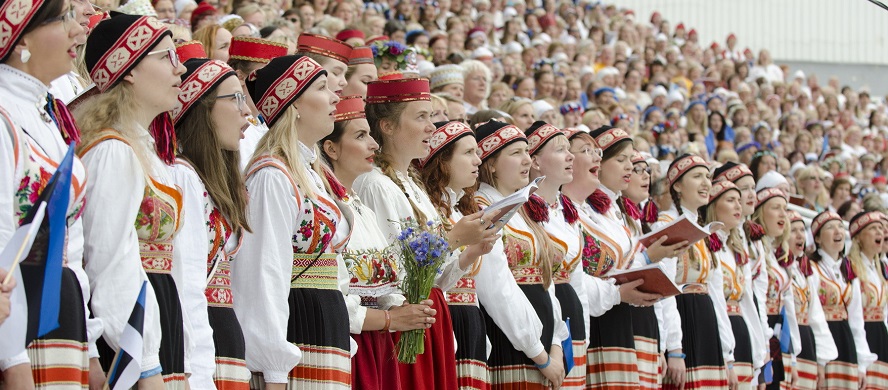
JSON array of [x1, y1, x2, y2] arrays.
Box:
[[0, 202, 46, 359]]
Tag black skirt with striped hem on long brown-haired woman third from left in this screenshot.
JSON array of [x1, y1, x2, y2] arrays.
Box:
[[207, 306, 250, 390]]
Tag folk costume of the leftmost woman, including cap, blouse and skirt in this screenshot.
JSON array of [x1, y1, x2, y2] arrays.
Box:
[[0, 8, 93, 380]]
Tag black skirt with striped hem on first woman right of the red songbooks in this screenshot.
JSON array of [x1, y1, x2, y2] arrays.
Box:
[[663, 294, 728, 389]]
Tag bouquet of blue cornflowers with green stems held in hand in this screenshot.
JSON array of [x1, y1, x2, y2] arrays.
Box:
[[395, 218, 450, 364]]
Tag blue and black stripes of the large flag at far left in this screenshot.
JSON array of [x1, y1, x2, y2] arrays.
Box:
[[21, 146, 74, 345]]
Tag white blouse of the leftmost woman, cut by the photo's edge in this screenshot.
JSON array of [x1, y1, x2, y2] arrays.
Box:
[[0, 64, 97, 370]]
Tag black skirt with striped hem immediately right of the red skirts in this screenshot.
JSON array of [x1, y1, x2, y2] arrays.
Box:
[[450, 305, 490, 390]]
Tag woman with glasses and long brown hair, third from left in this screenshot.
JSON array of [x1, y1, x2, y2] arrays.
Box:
[[171, 59, 250, 388]]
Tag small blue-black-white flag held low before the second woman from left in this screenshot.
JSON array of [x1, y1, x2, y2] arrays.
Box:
[[106, 281, 148, 390]]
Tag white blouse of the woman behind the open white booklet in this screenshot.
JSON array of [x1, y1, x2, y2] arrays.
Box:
[[475, 183, 570, 358]]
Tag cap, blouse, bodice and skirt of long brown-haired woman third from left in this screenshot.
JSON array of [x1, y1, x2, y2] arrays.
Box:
[[171, 59, 250, 390]]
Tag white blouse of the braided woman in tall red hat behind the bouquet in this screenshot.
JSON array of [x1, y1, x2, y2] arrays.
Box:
[[352, 168, 468, 292]]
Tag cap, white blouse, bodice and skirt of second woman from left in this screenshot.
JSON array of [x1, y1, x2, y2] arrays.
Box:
[[78, 14, 190, 389]]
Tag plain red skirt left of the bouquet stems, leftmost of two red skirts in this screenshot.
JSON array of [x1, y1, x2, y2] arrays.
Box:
[[352, 331, 402, 390]]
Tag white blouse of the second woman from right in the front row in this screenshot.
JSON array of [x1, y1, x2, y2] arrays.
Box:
[[808, 249, 878, 375]]
